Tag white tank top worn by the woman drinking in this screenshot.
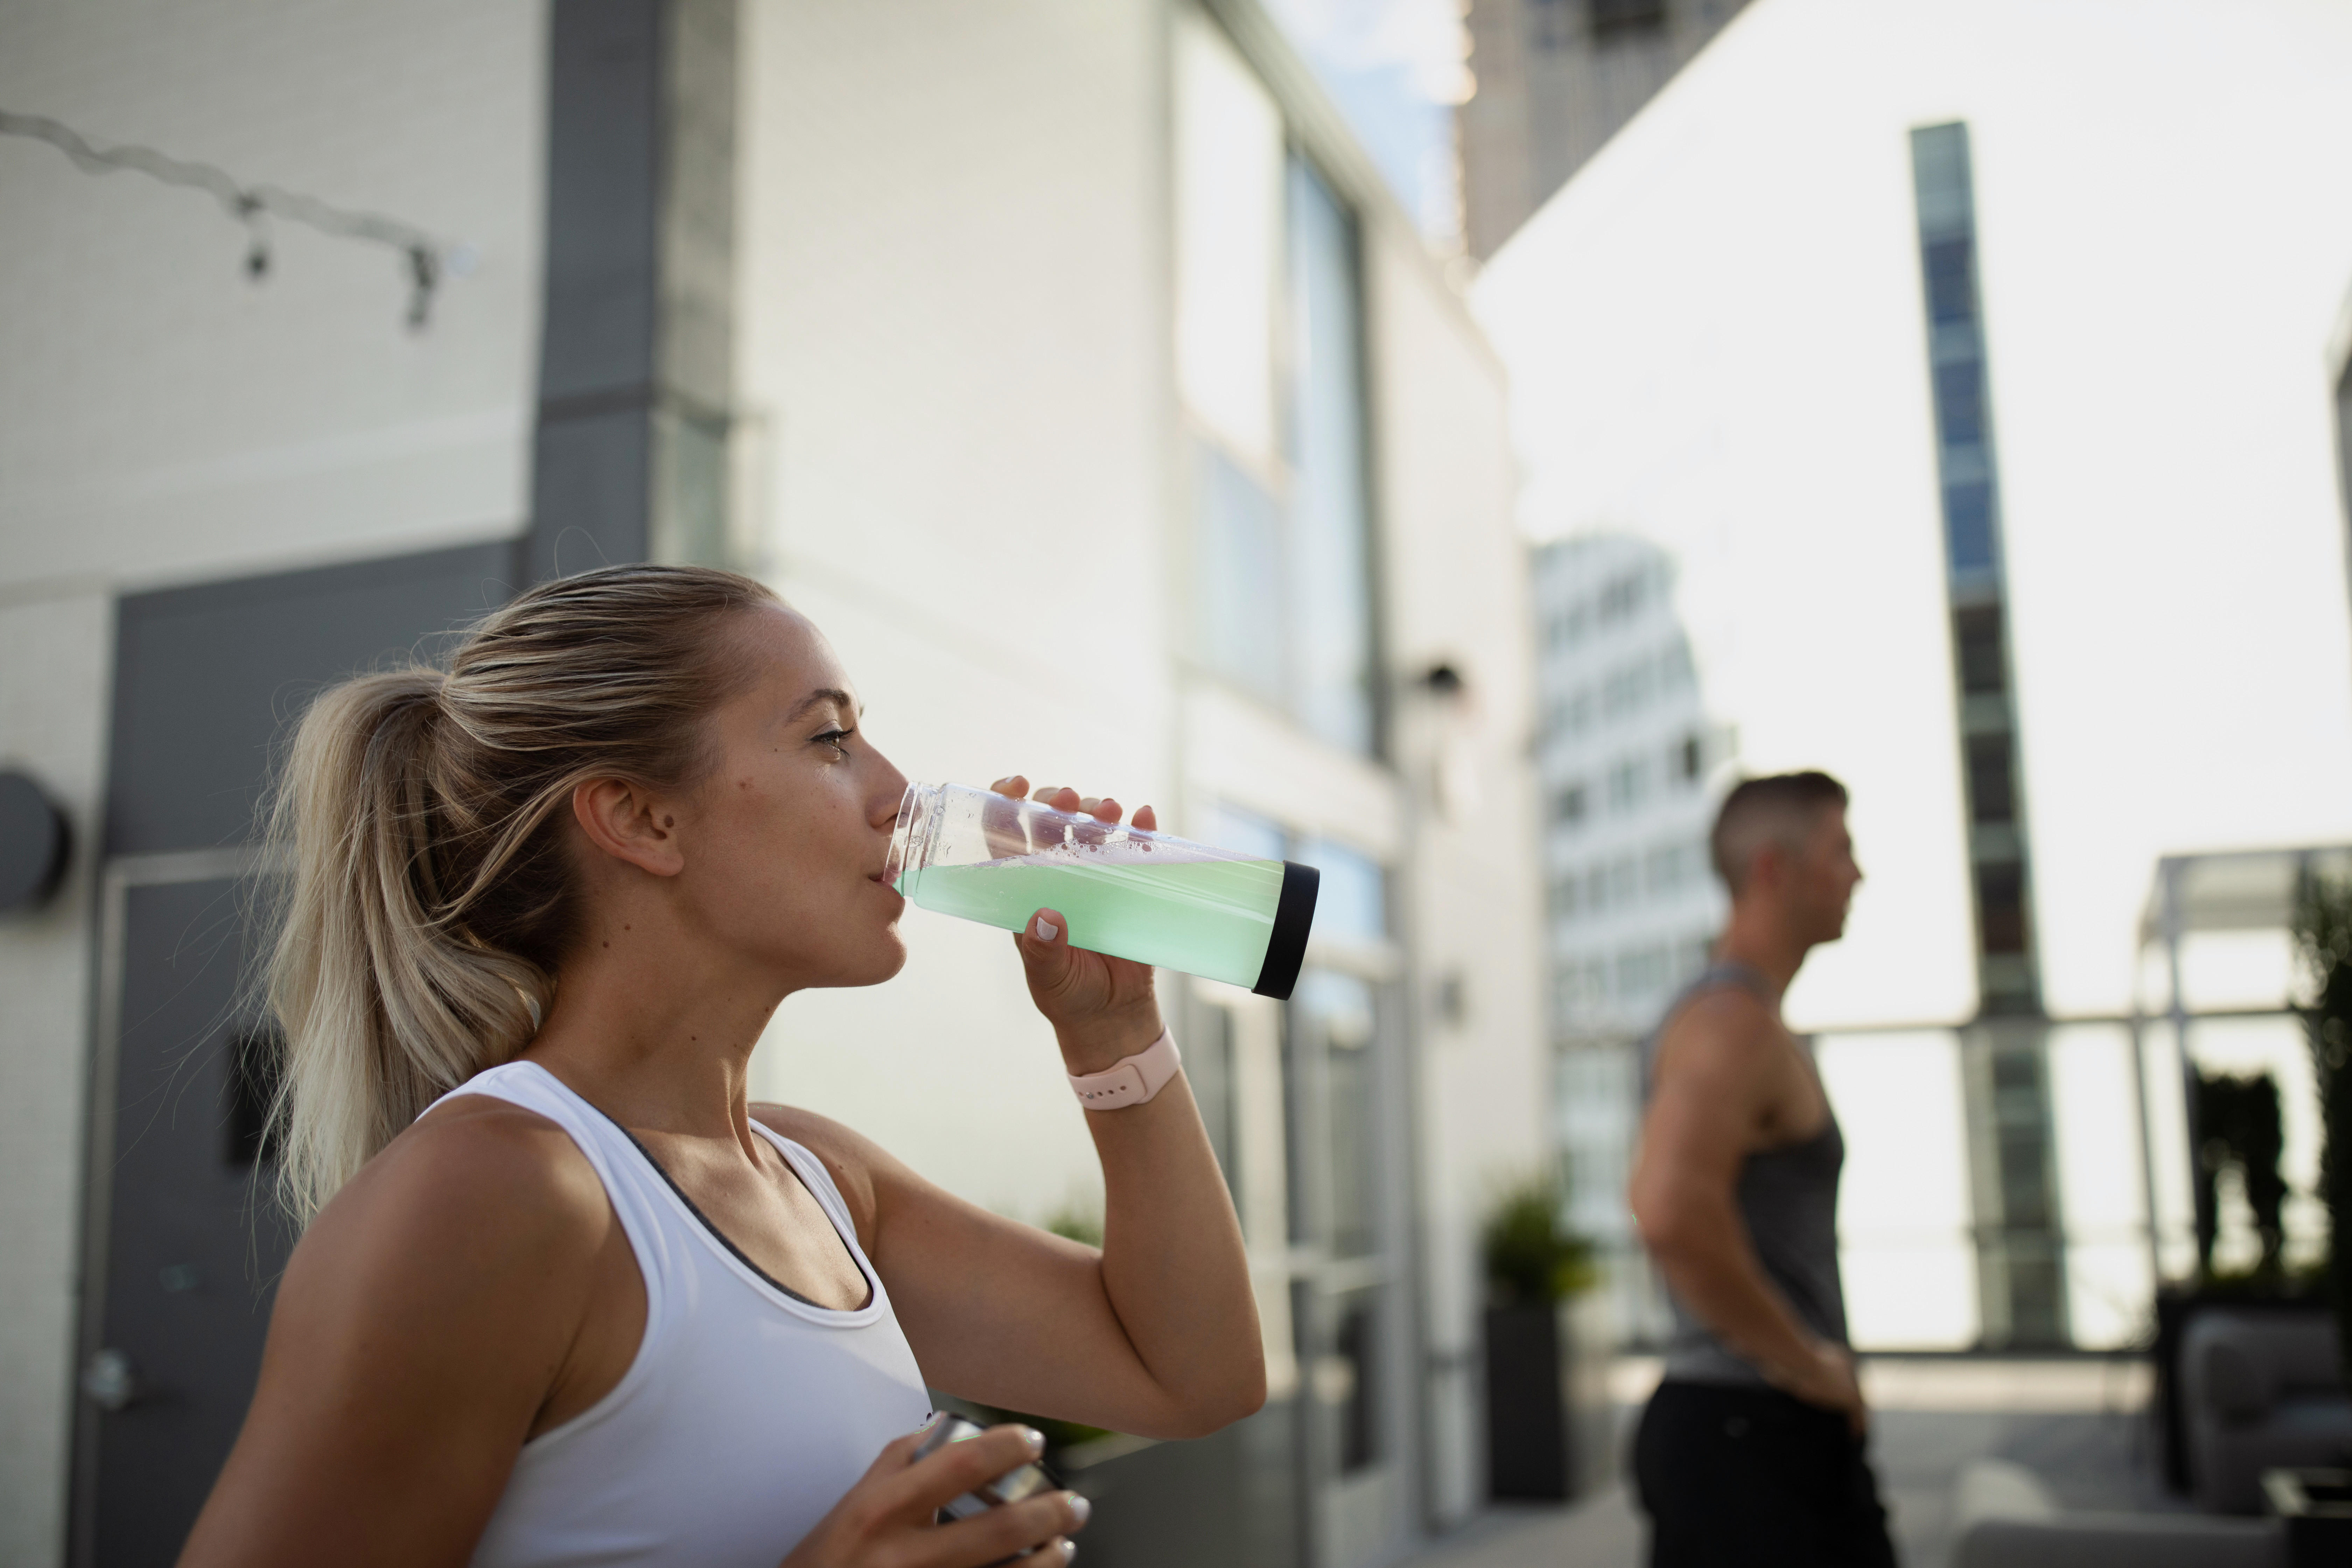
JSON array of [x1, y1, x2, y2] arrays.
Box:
[[442, 1063, 931, 1568]]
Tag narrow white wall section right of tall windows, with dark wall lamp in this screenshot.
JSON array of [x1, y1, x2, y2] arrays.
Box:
[[1366, 230, 1552, 1523]]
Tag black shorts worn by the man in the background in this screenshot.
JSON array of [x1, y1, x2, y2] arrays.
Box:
[[1632, 1382, 1896, 1568]]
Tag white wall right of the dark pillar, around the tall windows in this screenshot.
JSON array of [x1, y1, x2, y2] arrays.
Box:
[[738, 0, 1548, 1552]]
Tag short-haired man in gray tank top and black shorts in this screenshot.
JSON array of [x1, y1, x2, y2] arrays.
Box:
[[1630, 774, 1896, 1568]]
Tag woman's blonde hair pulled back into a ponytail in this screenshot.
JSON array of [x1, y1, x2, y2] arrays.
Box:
[[266, 567, 776, 1225]]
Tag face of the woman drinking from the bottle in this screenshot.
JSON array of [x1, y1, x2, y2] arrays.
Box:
[[680, 604, 905, 990]]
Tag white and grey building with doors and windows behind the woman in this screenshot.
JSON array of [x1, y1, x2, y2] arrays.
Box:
[[0, 0, 1550, 1568]]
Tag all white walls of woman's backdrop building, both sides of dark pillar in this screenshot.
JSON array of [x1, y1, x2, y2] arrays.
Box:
[[0, 0, 1543, 1563]]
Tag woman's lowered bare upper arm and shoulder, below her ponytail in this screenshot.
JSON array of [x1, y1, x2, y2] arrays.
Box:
[[181, 1098, 644, 1568]]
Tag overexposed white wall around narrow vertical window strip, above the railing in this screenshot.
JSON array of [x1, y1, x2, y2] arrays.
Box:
[[1477, 0, 2352, 1027]]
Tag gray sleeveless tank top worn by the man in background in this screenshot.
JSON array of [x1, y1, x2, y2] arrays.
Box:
[[1642, 964, 1846, 1385]]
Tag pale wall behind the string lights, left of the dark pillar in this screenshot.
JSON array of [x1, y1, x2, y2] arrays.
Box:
[[0, 0, 543, 1563]]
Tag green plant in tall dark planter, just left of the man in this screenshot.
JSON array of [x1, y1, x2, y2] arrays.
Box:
[[1479, 1173, 1595, 1502]]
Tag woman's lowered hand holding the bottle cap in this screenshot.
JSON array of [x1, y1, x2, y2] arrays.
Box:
[[783, 1427, 1091, 1568]]
